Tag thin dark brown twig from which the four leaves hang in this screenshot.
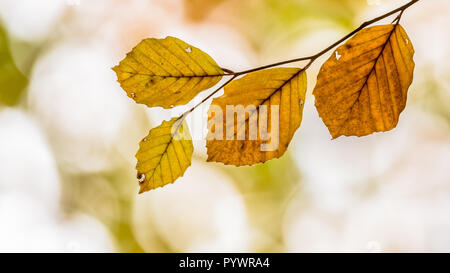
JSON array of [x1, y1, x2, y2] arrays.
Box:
[[179, 0, 420, 117]]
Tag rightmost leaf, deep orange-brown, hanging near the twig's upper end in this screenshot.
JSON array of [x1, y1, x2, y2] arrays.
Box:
[[313, 25, 414, 138]]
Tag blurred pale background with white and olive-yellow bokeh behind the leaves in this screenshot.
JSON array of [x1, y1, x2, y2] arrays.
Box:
[[0, 0, 450, 252]]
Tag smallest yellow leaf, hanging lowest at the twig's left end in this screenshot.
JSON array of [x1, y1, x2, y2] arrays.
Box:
[[136, 118, 194, 193]]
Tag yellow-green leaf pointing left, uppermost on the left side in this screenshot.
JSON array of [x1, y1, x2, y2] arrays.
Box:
[[113, 37, 223, 109]]
